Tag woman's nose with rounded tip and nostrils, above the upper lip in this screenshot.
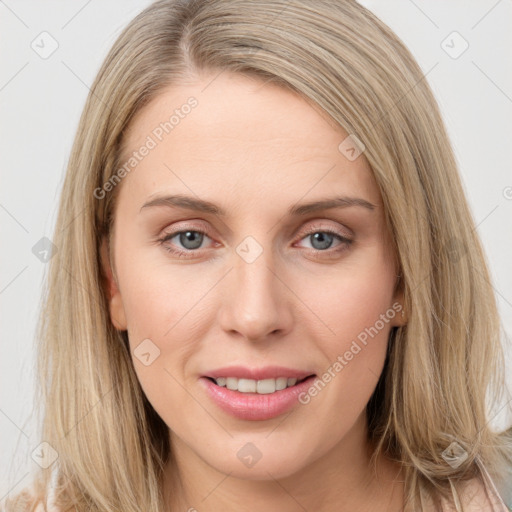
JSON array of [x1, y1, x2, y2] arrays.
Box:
[[219, 241, 293, 342]]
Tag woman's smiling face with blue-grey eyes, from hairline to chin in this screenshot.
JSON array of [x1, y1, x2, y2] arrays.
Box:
[[103, 72, 401, 479]]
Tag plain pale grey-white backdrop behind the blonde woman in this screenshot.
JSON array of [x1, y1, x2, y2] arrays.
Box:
[[0, 0, 512, 503]]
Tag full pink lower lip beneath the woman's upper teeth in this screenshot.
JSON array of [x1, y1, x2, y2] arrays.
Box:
[[199, 375, 316, 421]]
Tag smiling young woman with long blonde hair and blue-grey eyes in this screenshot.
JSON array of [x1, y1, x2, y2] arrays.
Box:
[[8, 0, 512, 512]]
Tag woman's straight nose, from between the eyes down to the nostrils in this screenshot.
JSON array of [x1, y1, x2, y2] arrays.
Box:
[[221, 236, 290, 340]]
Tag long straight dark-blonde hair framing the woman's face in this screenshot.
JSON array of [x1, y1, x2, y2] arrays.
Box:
[[5, 0, 512, 512]]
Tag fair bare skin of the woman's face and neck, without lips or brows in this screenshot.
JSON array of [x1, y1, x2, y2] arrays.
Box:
[[103, 72, 406, 512]]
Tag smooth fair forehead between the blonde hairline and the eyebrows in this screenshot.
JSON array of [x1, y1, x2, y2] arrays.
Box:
[[117, 72, 380, 209]]
